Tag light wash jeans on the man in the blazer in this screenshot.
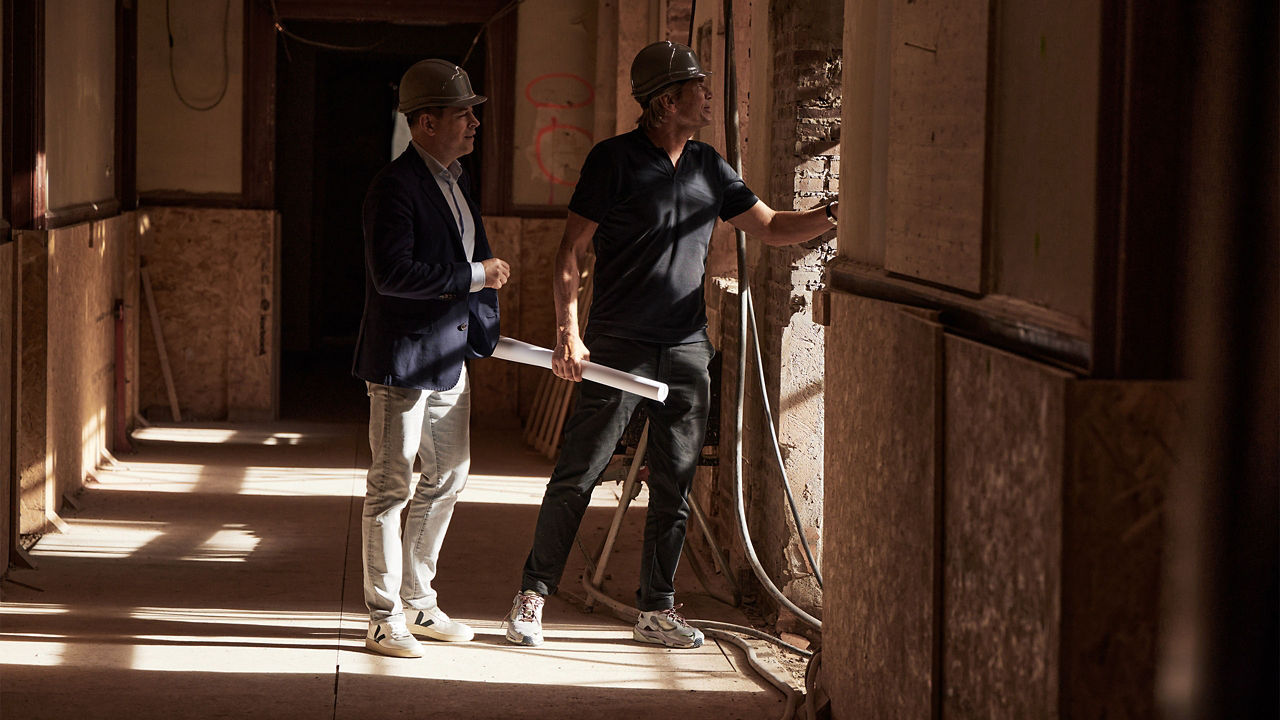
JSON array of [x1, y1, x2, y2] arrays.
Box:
[[361, 366, 471, 623]]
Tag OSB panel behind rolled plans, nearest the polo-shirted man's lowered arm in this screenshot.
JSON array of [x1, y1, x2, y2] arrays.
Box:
[[520, 218, 564, 418]]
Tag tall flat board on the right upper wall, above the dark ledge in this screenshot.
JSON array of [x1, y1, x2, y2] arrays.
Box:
[[884, 0, 989, 292]]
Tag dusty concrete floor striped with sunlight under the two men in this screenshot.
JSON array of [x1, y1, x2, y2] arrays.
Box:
[[0, 423, 783, 720]]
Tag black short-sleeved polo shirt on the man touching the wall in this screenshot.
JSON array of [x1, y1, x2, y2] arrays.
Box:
[[568, 128, 756, 343]]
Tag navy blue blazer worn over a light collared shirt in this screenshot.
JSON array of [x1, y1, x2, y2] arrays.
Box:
[[351, 145, 498, 391]]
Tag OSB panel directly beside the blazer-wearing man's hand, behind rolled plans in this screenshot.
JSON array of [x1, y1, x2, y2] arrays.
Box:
[[471, 212, 526, 427]]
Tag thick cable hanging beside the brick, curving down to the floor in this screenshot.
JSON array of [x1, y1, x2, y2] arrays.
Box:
[[724, 0, 822, 630]]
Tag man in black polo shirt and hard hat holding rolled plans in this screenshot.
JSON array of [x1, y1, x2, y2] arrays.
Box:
[[507, 37, 836, 647]]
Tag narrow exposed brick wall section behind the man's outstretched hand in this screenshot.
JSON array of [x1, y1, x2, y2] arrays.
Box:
[[744, 0, 844, 626]]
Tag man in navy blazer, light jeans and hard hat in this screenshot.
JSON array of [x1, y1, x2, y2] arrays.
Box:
[[352, 59, 511, 657]]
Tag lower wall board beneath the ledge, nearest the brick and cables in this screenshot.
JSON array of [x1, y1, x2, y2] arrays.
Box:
[[822, 293, 942, 719]]
